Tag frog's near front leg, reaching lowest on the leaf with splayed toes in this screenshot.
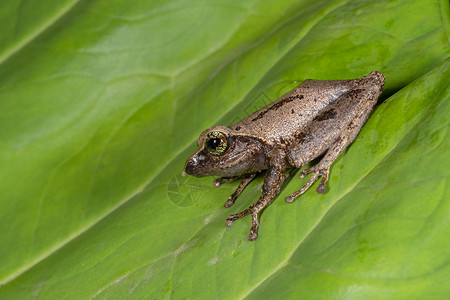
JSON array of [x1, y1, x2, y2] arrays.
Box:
[[225, 149, 286, 241]]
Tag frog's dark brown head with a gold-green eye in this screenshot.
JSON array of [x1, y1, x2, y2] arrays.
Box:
[[184, 126, 266, 177]]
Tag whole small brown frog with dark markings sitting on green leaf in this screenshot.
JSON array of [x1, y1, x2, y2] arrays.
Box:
[[183, 71, 385, 241]]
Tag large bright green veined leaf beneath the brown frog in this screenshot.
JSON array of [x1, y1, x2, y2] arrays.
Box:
[[0, 0, 450, 299]]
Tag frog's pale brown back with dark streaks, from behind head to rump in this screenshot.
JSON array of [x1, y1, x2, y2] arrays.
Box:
[[230, 79, 355, 143]]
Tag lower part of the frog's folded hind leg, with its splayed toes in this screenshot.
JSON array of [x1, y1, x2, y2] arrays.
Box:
[[285, 107, 372, 202]]
